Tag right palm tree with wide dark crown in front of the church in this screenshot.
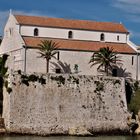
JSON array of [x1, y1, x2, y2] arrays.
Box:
[[89, 47, 121, 75]]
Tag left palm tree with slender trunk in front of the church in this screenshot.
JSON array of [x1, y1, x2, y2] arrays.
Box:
[[38, 40, 58, 73]]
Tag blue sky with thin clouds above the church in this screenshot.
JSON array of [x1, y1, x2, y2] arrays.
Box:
[[0, 0, 140, 45]]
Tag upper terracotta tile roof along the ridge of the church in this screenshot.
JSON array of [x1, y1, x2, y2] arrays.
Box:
[[15, 15, 128, 33]]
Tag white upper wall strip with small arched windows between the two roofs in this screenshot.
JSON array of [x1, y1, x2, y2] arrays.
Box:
[[21, 26, 127, 43]]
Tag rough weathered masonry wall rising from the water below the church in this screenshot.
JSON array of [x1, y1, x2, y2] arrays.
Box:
[[3, 74, 128, 135]]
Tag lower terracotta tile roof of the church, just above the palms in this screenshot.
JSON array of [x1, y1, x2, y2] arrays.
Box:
[[23, 37, 136, 54]]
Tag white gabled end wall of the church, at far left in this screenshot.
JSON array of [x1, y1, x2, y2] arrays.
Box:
[[0, 14, 25, 71]]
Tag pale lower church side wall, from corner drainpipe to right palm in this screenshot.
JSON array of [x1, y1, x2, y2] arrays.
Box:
[[26, 49, 97, 75]]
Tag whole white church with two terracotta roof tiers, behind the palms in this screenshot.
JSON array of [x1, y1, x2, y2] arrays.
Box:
[[0, 14, 140, 80]]
